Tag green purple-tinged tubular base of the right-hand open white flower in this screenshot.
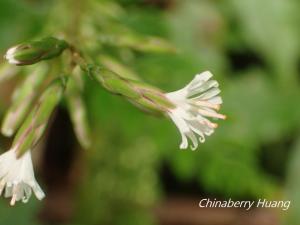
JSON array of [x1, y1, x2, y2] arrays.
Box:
[[88, 66, 174, 114]]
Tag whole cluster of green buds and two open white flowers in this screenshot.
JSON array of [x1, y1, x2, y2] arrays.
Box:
[[0, 35, 226, 205]]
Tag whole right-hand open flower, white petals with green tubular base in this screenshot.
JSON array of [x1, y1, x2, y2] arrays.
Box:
[[86, 65, 225, 150]]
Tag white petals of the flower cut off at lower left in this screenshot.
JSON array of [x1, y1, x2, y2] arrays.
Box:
[[0, 149, 45, 205]]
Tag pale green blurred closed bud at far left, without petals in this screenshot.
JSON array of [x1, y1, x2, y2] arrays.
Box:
[[1, 64, 48, 137]]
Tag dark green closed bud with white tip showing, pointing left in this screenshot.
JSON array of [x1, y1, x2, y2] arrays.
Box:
[[4, 37, 68, 65]]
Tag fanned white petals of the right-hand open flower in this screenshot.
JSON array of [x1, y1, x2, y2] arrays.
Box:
[[166, 71, 226, 150]]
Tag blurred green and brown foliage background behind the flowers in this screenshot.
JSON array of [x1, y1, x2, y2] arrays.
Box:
[[0, 0, 300, 225]]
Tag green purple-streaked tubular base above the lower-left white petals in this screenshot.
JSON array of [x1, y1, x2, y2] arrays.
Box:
[[13, 77, 67, 156]]
